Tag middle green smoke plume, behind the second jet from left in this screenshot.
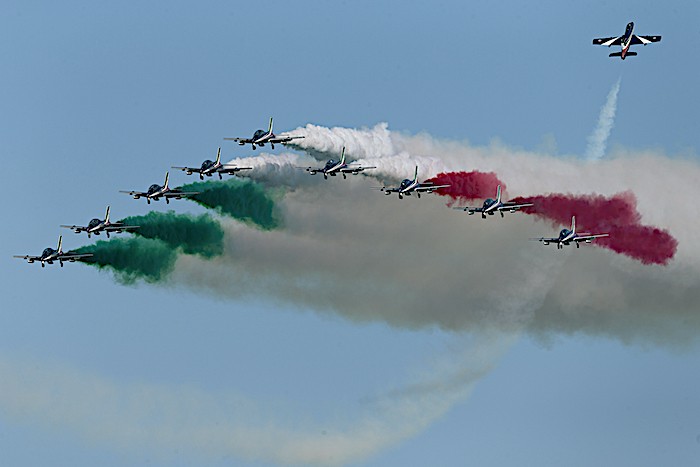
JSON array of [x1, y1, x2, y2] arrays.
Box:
[[120, 211, 224, 258]]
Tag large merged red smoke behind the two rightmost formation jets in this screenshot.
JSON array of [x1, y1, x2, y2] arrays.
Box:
[[512, 192, 678, 265]]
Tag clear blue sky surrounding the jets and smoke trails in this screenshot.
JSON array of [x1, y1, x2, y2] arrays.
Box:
[[0, 0, 700, 466]]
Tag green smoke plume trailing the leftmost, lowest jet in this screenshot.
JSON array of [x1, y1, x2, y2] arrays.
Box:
[[76, 237, 177, 284]]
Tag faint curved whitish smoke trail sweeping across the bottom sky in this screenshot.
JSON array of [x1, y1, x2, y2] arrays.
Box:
[[0, 334, 514, 465]]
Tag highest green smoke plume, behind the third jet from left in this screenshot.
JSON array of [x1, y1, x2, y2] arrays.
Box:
[[182, 178, 280, 230]]
